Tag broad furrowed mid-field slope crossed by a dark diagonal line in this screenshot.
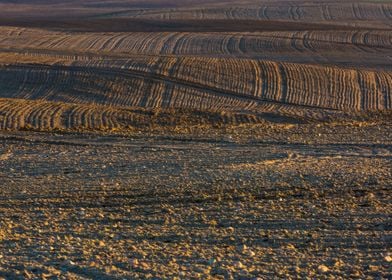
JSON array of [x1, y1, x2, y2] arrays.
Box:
[[0, 57, 392, 111]]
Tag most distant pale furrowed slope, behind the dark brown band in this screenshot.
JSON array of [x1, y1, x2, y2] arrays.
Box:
[[84, 1, 392, 28]]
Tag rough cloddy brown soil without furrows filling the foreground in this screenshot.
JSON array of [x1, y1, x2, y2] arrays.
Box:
[[0, 124, 392, 279]]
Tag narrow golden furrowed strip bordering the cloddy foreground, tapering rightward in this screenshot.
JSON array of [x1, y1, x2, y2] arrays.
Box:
[[0, 98, 278, 131]]
